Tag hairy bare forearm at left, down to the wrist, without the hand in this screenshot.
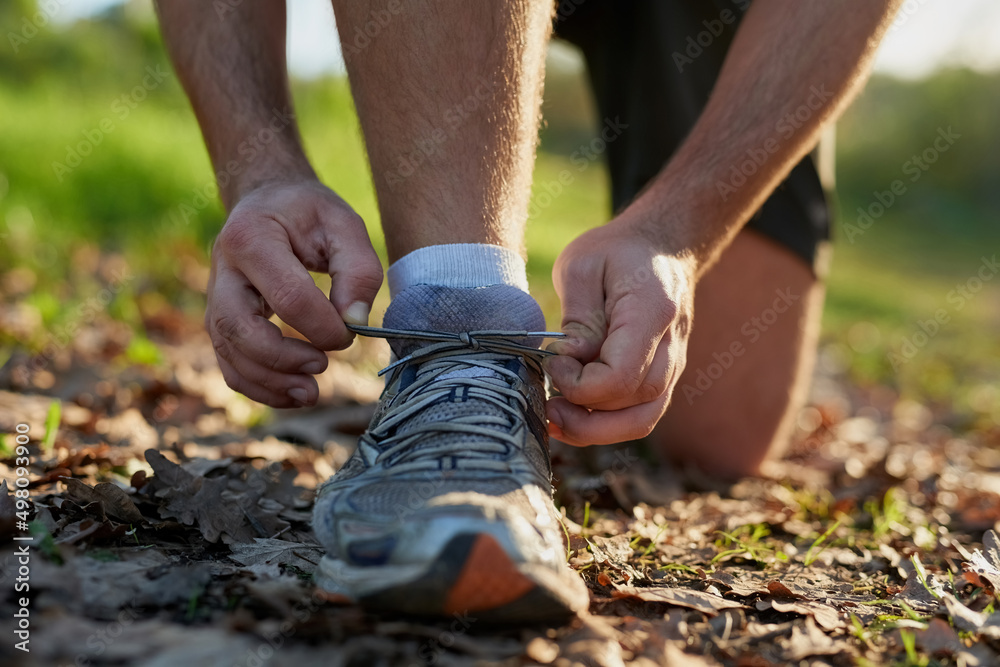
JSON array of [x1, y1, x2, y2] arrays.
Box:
[[156, 0, 315, 210]]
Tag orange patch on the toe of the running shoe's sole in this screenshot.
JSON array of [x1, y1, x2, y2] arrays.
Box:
[[444, 535, 535, 614]]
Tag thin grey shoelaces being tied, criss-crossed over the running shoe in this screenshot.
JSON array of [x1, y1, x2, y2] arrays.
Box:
[[348, 325, 564, 472]]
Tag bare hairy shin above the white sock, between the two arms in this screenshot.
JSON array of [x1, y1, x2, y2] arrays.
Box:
[[333, 0, 552, 262]]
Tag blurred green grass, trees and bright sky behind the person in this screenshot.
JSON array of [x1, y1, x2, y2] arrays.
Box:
[[0, 0, 1000, 432]]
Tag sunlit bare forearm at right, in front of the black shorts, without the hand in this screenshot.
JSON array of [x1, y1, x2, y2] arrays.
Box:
[[623, 0, 900, 275]]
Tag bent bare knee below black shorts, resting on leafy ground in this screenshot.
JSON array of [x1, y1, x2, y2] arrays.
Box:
[[650, 230, 824, 477]]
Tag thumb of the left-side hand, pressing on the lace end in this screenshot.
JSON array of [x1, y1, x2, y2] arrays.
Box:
[[329, 228, 382, 326]]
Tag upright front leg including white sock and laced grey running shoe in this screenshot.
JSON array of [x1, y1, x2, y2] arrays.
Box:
[[313, 0, 589, 622]]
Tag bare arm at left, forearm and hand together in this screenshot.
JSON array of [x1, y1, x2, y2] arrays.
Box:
[[157, 0, 382, 408]]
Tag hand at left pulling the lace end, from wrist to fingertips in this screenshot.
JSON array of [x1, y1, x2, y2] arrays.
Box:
[[205, 180, 382, 408]]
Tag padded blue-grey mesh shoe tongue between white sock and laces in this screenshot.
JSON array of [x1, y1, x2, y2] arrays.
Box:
[[382, 285, 545, 358]]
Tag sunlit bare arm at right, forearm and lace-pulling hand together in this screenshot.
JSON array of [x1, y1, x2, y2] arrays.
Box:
[[547, 0, 899, 472]]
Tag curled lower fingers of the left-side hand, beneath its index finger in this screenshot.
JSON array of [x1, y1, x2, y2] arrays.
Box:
[[205, 267, 328, 407]]
